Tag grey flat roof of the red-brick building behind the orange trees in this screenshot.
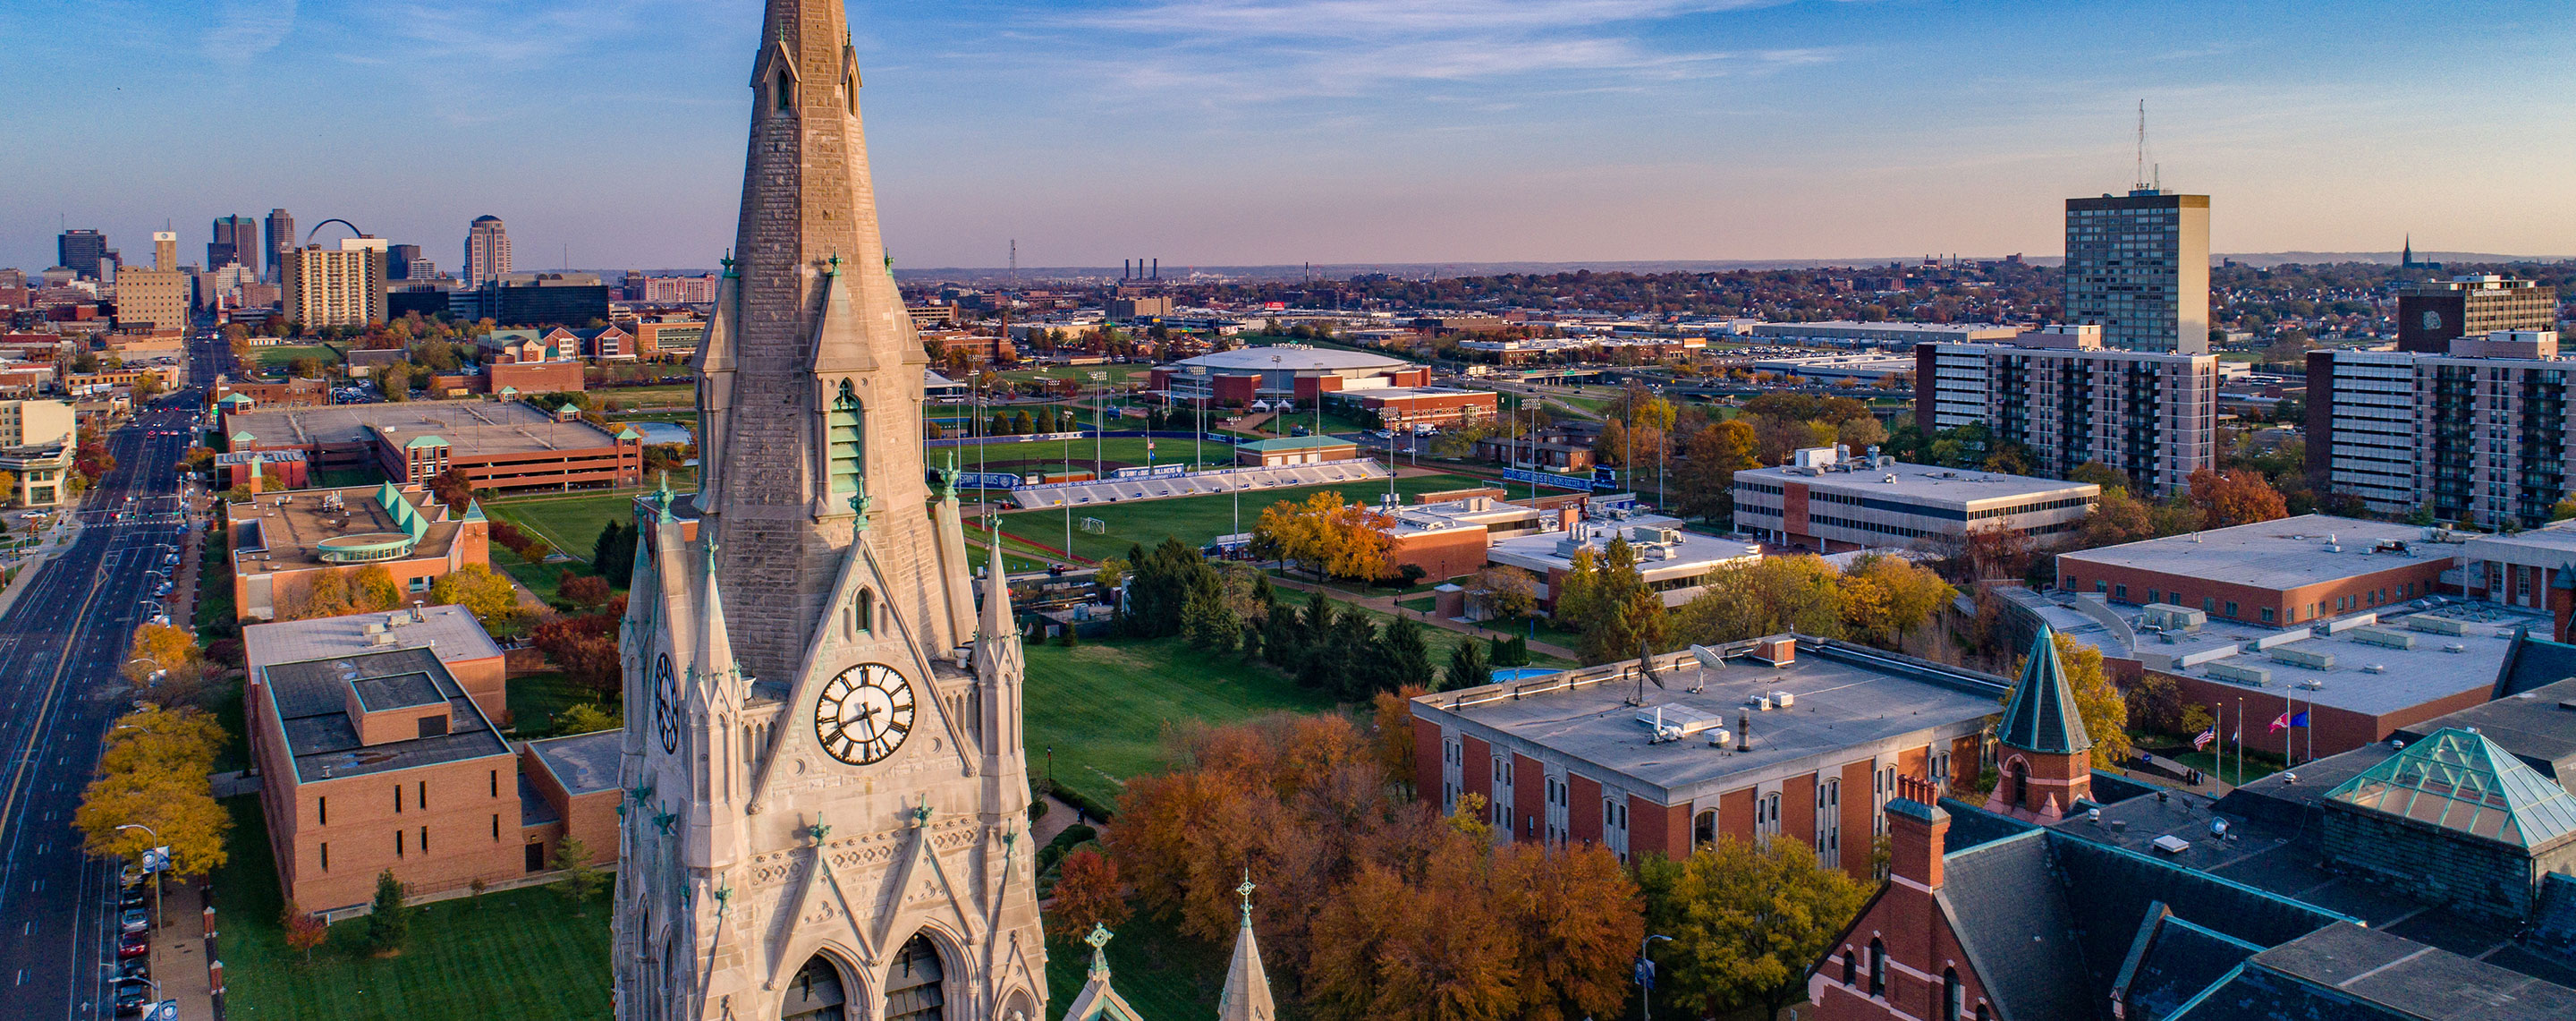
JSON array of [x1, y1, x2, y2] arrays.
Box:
[[1414, 640, 2012, 804]]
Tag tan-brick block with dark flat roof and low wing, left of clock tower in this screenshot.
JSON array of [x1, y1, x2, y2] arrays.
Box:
[[242, 606, 623, 913]]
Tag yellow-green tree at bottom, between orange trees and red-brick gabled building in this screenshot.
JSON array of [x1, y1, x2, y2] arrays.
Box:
[[1639, 838, 1870, 1018]]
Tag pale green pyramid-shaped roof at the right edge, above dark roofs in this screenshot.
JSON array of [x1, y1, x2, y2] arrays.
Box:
[[2326, 727, 2576, 848]]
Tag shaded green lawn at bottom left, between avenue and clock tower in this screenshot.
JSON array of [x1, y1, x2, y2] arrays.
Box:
[[214, 796, 608, 1021]]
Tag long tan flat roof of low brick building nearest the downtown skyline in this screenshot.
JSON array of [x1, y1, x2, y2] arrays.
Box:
[[225, 400, 615, 454]]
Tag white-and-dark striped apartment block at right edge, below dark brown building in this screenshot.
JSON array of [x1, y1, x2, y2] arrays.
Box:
[[2308, 330, 2576, 529]]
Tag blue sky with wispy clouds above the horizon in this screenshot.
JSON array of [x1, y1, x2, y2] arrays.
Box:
[[0, 0, 2576, 268]]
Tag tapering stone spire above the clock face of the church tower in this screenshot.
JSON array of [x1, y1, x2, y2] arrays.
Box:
[[698, 0, 963, 681]]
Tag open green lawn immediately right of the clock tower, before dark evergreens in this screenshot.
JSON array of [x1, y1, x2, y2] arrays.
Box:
[[1028, 637, 1335, 804]]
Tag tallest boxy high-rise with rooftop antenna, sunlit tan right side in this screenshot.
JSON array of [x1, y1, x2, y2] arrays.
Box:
[[2066, 188, 2210, 353]]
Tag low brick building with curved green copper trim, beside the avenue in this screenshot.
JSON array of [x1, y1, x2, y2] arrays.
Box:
[[219, 479, 492, 621]]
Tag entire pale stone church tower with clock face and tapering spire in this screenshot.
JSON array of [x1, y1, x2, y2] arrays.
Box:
[[611, 0, 1046, 1021]]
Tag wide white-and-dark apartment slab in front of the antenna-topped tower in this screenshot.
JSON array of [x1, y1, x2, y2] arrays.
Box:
[[1914, 325, 2218, 495]]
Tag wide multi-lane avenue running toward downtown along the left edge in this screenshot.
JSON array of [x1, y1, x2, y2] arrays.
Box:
[[0, 343, 229, 1021]]
